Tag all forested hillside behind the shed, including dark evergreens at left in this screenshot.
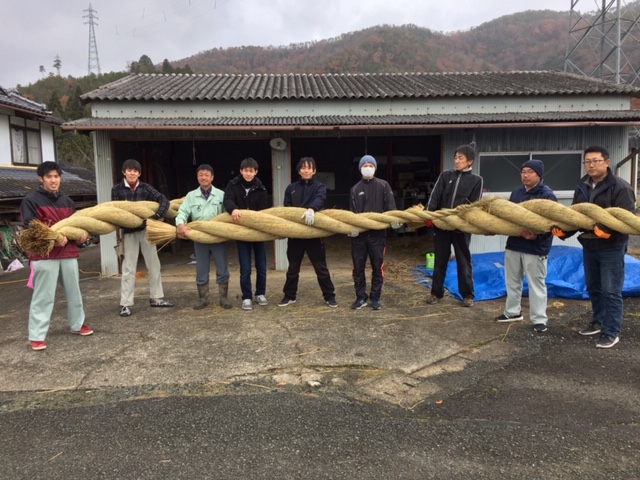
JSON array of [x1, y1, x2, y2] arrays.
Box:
[[13, 4, 640, 164]]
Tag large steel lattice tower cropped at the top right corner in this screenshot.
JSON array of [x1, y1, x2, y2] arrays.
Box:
[[564, 0, 640, 86]]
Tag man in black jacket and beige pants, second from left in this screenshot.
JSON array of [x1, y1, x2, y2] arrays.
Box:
[[111, 159, 173, 317]]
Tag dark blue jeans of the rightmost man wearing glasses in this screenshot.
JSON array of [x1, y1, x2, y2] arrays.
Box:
[[582, 243, 627, 337]]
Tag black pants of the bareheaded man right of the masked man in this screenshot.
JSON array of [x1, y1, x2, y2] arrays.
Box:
[[431, 228, 474, 298]]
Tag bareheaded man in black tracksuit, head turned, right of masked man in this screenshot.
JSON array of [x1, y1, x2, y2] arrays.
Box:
[[426, 145, 482, 307]]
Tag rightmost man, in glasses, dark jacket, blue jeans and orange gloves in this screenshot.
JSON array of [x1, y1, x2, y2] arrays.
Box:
[[552, 146, 636, 348]]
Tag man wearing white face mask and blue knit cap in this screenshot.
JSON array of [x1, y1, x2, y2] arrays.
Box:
[[350, 155, 401, 310]]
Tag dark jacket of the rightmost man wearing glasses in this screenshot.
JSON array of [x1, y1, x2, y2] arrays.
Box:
[[572, 168, 636, 250]]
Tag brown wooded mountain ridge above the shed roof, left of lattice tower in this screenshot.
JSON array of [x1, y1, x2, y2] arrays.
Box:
[[172, 10, 569, 74]]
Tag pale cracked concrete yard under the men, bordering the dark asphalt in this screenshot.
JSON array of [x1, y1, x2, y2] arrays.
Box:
[[0, 237, 584, 408]]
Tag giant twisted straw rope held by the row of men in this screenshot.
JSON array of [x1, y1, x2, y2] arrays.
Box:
[[20, 197, 640, 253]]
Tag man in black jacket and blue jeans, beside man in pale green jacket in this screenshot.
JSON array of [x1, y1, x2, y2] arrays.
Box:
[[222, 158, 268, 310]]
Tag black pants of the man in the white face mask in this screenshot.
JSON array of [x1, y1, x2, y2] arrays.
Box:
[[351, 236, 387, 300]]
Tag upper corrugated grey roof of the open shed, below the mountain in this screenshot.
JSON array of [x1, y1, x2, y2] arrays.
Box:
[[82, 71, 640, 102]]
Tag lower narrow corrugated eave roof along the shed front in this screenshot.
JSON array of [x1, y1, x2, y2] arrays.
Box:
[[62, 110, 640, 130]]
